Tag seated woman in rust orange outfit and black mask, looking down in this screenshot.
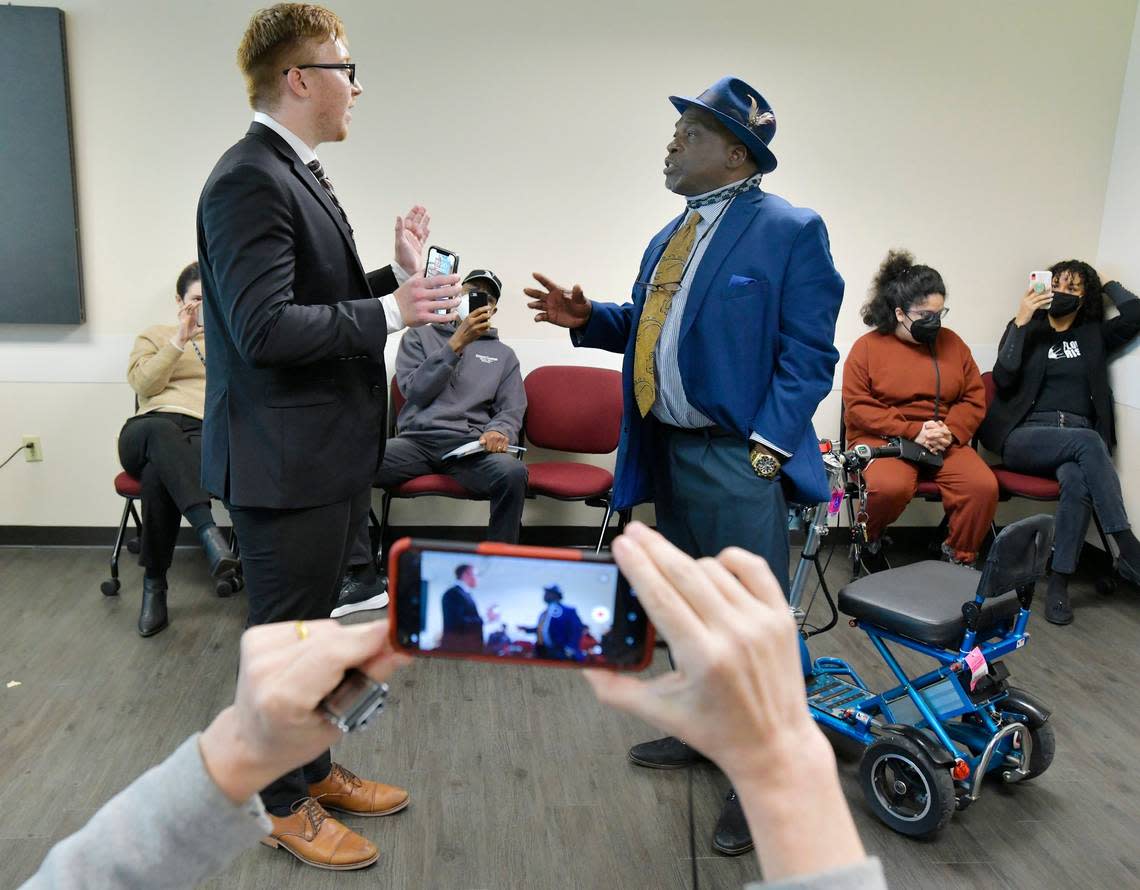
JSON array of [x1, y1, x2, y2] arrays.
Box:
[[844, 251, 998, 570]]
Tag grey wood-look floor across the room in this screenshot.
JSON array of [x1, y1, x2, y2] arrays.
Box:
[[0, 537, 1140, 890]]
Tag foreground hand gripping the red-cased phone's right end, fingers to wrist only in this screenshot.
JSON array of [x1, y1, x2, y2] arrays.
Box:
[[588, 522, 819, 777]]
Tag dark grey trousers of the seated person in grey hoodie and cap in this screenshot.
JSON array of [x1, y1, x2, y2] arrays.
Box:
[[346, 434, 527, 565]]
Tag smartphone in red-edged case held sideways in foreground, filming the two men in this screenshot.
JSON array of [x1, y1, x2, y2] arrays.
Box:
[[389, 538, 653, 670]]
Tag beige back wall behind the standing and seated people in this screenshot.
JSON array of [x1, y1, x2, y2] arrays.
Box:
[[0, 0, 1140, 525]]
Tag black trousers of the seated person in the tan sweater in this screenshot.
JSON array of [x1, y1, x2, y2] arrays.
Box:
[[119, 413, 210, 572]]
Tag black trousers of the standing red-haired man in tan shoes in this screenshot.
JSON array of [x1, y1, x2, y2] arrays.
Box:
[[229, 491, 371, 816]]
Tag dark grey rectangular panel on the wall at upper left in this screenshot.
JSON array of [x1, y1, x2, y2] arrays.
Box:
[[0, 6, 83, 325]]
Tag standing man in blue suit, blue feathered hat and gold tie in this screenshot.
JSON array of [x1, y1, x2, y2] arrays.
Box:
[[527, 77, 844, 855]]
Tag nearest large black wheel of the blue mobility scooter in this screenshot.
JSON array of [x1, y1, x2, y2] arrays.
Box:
[[858, 735, 956, 838]]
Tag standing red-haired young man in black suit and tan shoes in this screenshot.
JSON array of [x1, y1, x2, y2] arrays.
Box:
[[197, 3, 459, 869]]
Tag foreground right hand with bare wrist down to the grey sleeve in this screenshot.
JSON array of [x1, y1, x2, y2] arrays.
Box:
[[586, 522, 864, 881]]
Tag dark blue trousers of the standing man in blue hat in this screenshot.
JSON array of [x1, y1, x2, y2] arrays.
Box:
[[653, 425, 789, 596]]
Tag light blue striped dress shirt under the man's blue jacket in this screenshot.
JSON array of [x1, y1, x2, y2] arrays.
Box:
[[650, 179, 791, 457]]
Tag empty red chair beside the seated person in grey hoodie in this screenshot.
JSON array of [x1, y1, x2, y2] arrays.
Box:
[[523, 365, 628, 552]]
